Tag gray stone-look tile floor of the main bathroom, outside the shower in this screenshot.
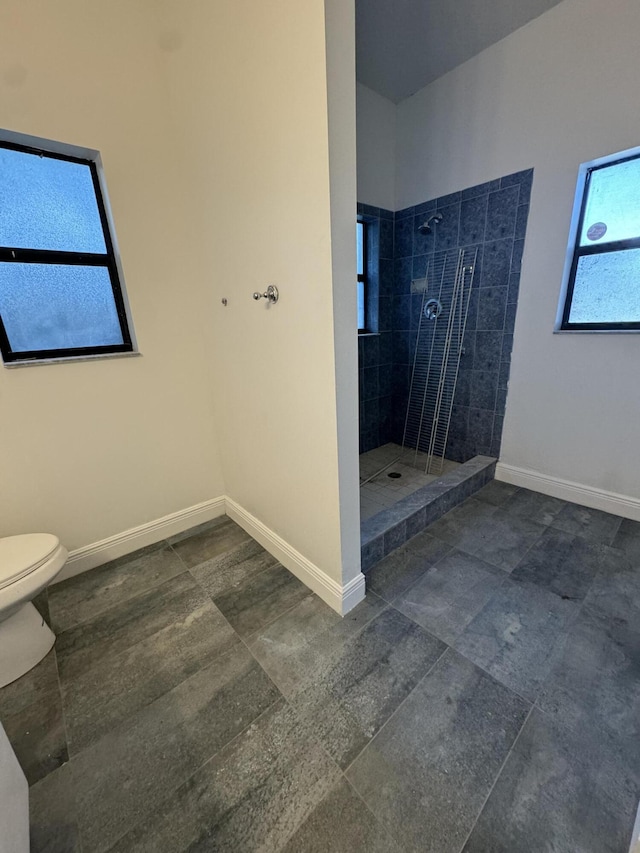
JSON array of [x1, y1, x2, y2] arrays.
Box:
[[0, 492, 640, 853]]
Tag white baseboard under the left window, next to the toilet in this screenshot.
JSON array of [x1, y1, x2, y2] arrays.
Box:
[[54, 496, 225, 583]]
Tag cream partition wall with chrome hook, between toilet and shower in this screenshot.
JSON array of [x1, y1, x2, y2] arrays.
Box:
[[159, 0, 359, 582]]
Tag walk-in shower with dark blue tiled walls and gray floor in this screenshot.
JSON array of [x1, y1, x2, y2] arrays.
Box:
[[358, 169, 533, 568]]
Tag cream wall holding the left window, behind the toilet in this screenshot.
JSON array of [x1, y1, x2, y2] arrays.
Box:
[[0, 0, 224, 549]]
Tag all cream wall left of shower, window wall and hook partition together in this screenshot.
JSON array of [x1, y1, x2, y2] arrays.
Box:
[[0, 0, 359, 583]]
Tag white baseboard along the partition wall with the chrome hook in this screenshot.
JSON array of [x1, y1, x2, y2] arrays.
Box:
[[226, 498, 365, 616]]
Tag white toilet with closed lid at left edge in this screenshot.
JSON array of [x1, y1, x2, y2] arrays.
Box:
[[0, 533, 67, 687]]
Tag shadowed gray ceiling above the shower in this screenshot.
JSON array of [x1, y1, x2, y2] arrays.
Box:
[[356, 0, 560, 103]]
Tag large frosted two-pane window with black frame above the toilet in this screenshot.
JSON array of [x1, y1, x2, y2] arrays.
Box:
[[0, 138, 133, 363]]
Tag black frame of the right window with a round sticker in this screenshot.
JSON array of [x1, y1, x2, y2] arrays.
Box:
[[556, 149, 640, 332]]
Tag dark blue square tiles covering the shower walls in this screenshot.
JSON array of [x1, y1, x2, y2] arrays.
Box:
[[358, 169, 533, 462]]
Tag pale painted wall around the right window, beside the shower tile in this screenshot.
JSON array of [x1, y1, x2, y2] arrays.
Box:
[[396, 0, 640, 498]]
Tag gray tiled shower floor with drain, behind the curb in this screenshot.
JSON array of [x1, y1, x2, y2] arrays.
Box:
[[360, 443, 460, 521]]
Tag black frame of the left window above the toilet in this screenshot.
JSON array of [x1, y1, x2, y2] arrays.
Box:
[[0, 139, 136, 364]]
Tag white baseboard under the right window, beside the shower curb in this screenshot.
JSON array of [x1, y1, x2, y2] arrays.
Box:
[[496, 462, 640, 521]]
